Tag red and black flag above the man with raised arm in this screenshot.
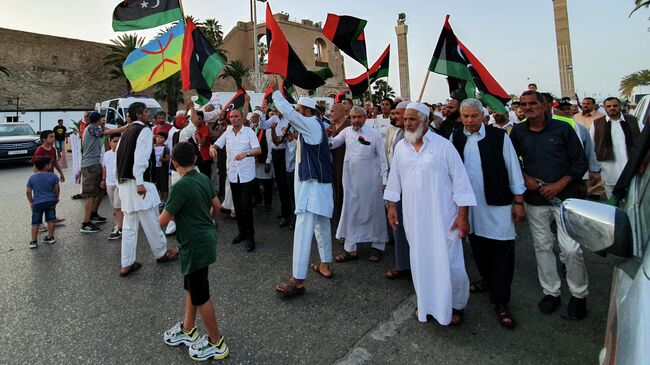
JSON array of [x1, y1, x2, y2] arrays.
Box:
[[264, 3, 333, 90]]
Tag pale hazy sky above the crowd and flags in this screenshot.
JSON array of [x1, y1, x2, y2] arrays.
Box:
[[0, 0, 650, 101]]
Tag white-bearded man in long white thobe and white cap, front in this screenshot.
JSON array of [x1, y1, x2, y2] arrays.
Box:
[[384, 103, 476, 325]]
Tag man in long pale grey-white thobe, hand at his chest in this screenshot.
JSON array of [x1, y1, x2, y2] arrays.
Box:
[[330, 106, 388, 262]]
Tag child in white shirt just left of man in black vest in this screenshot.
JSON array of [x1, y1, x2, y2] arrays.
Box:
[[99, 132, 124, 240]]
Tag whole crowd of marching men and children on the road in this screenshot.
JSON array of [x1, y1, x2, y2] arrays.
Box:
[[27, 80, 643, 360]]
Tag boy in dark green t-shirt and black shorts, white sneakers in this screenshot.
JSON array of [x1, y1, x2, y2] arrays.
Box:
[[160, 142, 229, 361]]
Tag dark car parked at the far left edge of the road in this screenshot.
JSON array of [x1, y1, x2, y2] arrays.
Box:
[[0, 123, 41, 162]]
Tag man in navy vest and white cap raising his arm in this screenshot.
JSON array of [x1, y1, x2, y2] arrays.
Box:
[[269, 78, 334, 297]]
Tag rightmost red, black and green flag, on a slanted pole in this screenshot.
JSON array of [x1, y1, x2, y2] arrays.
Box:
[[429, 15, 510, 113]]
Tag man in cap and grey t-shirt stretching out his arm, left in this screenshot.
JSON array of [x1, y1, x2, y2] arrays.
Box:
[[80, 112, 126, 233]]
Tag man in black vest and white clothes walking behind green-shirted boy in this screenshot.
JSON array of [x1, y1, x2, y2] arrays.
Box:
[[117, 102, 178, 277]]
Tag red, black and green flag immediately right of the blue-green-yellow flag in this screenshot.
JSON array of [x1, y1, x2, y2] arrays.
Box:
[[181, 18, 226, 105]]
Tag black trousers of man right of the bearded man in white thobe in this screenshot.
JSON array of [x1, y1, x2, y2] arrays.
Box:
[[469, 234, 515, 305]]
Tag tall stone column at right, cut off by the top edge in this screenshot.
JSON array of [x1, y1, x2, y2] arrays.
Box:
[[553, 0, 575, 98]]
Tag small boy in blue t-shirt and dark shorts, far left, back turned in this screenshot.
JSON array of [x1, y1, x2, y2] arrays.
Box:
[[26, 156, 60, 248]]
